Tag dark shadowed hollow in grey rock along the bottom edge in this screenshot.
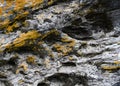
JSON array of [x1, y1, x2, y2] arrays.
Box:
[[47, 73, 88, 86]]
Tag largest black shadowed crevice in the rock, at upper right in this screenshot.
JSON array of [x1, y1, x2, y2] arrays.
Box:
[[62, 13, 113, 40]]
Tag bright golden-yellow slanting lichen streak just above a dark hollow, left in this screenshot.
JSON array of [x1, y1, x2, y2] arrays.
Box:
[[6, 30, 41, 50]]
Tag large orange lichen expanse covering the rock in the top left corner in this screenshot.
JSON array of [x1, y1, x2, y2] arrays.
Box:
[[0, 0, 55, 32]]
